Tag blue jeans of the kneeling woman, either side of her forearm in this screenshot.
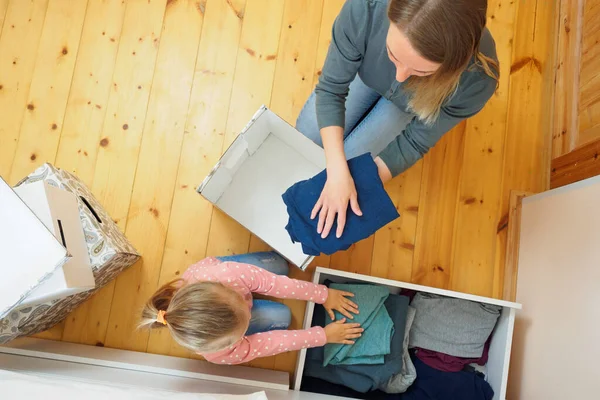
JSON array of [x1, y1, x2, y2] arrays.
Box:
[[296, 76, 413, 160]]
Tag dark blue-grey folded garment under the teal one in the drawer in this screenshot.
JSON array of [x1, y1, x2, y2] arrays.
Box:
[[304, 295, 408, 393]]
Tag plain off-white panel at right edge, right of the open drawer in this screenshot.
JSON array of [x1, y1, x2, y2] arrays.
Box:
[[507, 176, 600, 400]]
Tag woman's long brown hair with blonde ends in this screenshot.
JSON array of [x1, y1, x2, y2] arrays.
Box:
[[388, 0, 498, 124]]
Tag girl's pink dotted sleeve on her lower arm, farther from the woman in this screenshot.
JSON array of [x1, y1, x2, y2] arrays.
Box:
[[202, 326, 327, 365]]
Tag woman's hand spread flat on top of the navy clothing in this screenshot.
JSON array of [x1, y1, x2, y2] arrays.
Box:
[[310, 160, 362, 239]]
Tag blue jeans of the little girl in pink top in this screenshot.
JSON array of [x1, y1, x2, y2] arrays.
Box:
[[217, 252, 292, 336]]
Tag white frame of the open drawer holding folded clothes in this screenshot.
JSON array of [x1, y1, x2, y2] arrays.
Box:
[[293, 267, 521, 400]]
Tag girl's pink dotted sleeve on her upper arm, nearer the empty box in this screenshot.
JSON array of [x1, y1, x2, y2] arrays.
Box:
[[229, 263, 328, 304]]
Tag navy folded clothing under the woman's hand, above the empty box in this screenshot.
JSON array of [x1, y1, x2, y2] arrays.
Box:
[[282, 153, 400, 256]]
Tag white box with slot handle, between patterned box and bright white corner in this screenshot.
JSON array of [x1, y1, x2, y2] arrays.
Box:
[[14, 181, 95, 306]]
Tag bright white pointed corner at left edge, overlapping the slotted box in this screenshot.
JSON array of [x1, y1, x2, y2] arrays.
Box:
[[0, 178, 70, 319]]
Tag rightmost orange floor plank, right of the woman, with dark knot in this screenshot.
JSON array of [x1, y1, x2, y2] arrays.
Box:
[[492, 2, 558, 297]]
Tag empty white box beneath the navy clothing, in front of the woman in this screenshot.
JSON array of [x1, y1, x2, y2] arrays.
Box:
[[198, 106, 325, 269]]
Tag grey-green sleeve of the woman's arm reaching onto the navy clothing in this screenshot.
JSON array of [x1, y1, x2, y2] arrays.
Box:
[[315, 0, 368, 129]]
